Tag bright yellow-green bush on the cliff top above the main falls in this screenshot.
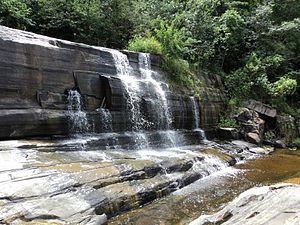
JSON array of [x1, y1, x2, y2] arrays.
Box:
[[128, 37, 163, 55]]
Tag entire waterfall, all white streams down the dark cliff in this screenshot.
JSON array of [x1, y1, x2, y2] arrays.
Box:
[[68, 49, 206, 149]]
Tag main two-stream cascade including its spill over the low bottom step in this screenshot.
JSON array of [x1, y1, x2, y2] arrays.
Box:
[[108, 50, 185, 148]]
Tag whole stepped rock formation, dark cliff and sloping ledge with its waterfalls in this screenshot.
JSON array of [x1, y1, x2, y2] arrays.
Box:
[[0, 26, 231, 224]]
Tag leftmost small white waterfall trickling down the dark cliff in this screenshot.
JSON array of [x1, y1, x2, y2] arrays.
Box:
[[67, 90, 89, 133]]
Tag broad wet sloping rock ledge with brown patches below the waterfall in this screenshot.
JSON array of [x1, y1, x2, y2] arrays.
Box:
[[0, 138, 251, 224]]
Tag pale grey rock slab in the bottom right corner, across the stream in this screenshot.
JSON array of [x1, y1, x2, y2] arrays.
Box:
[[190, 184, 300, 225]]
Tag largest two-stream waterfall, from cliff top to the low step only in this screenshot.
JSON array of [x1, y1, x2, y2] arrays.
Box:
[[111, 50, 172, 131]]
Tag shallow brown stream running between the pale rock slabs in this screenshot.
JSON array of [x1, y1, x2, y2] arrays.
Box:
[[109, 149, 300, 225]]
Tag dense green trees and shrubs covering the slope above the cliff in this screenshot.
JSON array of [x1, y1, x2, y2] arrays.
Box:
[[0, 0, 300, 111]]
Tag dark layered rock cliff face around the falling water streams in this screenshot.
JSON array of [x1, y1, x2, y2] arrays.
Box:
[[0, 26, 224, 139]]
